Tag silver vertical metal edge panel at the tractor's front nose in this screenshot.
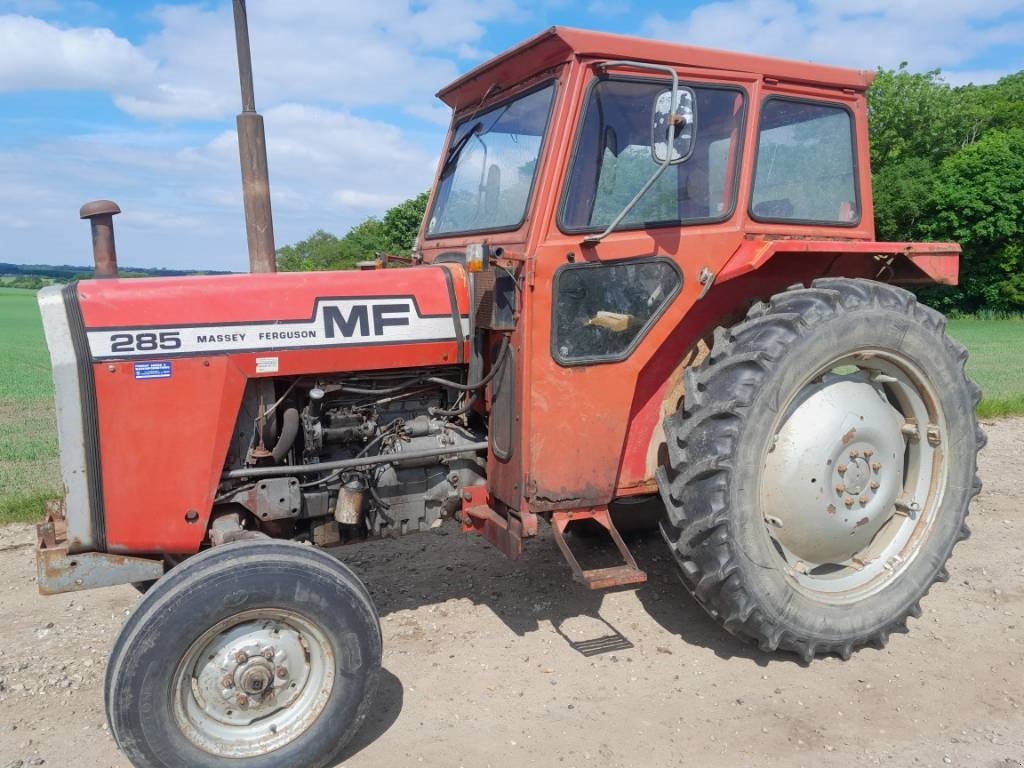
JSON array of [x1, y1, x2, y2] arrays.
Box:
[[39, 286, 94, 552]]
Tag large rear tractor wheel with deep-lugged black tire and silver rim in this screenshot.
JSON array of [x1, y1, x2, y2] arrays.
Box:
[[658, 279, 985, 662]]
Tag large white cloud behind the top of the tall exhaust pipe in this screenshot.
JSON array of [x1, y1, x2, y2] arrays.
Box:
[[116, 0, 515, 120]]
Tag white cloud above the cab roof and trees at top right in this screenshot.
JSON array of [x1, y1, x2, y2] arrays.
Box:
[[644, 0, 1024, 70]]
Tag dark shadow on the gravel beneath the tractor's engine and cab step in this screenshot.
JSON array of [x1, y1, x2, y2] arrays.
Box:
[[334, 514, 799, 666]]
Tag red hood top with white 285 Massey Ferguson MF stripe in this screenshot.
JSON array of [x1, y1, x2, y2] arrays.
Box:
[[50, 265, 468, 364]]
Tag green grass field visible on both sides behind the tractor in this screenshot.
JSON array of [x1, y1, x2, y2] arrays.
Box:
[[0, 288, 1024, 523]]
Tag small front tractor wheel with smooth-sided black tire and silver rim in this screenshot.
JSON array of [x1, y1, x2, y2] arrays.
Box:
[[105, 540, 381, 768]]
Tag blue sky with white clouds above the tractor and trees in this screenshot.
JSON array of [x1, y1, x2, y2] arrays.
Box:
[[0, 0, 1024, 271]]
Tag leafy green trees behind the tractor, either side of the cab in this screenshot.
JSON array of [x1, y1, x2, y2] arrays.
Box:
[[278, 62, 1024, 312]]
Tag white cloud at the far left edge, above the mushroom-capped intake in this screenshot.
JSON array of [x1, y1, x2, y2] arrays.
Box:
[[0, 14, 156, 92]]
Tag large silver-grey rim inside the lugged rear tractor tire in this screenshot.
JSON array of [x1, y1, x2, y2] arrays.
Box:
[[759, 349, 947, 604]]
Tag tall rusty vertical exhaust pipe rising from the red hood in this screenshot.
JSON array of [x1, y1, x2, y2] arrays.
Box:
[[233, 0, 278, 272]]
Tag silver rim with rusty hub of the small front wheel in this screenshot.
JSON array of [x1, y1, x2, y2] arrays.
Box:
[[171, 608, 335, 758]]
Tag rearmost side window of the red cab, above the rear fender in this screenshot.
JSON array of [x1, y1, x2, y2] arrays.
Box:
[[751, 98, 860, 226]]
